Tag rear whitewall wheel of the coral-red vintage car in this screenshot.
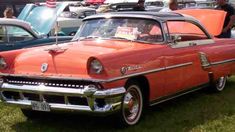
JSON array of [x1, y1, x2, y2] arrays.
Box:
[[211, 76, 228, 92]]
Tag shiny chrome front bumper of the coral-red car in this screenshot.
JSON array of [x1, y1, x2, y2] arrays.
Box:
[[0, 83, 126, 113]]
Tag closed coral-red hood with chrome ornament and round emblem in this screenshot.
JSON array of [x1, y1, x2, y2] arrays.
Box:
[[8, 40, 158, 78]]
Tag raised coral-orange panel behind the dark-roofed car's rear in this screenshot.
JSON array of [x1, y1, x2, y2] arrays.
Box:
[[175, 9, 226, 36]]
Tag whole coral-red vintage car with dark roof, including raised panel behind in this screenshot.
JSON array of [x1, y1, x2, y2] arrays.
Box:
[[0, 10, 235, 125]]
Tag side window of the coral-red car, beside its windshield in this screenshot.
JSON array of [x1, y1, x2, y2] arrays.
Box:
[[167, 21, 209, 42]]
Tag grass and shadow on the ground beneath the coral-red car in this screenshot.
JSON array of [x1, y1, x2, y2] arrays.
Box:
[[0, 76, 235, 132]]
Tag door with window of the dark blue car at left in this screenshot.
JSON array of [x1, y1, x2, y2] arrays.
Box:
[[0, 25, 37, 51]]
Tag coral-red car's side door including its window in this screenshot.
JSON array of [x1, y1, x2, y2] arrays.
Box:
[[164, 20, 211, 95]]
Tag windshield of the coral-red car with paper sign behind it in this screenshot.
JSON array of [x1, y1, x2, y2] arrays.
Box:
[[73, 18, 163, 42]]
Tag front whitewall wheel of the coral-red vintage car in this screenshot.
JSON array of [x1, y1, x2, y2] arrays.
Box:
[[120, 83, 143, 126]]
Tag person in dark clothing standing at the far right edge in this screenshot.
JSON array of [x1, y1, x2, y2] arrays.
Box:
[[216, 0, 235, 38]]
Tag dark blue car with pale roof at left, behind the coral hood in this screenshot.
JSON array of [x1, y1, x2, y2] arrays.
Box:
[[0, 18, 72, 51]]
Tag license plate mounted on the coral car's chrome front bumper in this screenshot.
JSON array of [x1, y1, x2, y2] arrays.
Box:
[[31, 101, 51, 111]]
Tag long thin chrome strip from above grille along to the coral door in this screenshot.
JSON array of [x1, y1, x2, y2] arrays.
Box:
[[0, 62, 193, 83]]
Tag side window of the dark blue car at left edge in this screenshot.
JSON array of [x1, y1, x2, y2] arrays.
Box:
[[3, 26, 34, 43]]
